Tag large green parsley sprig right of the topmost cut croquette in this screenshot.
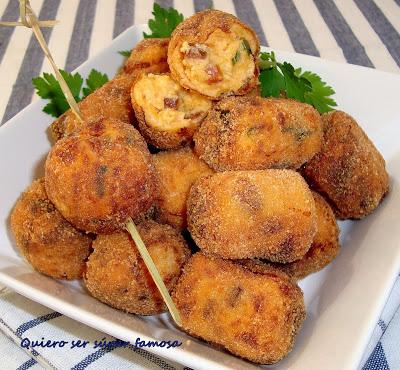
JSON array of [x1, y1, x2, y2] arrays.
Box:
[[259, 51, 337, 113]]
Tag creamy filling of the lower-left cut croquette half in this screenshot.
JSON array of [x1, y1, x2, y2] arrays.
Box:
[[133, 74, 211, 131]]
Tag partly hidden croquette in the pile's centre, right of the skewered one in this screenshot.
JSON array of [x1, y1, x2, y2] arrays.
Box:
[[153, 147, 214, 230]]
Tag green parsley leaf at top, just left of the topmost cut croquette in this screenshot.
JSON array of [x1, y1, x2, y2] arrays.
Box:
[[143, 3, 183, 38]]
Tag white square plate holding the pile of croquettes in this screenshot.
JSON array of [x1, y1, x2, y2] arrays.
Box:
[[0, 26, 400, 370]]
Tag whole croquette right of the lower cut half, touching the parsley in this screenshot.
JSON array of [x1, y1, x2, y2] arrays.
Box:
[[194, 96, 322, 171]]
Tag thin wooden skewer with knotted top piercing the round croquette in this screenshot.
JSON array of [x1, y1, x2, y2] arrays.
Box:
[[0, 0, 181, 326]]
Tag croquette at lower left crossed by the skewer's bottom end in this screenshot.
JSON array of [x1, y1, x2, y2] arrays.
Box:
[[84, 220, 190, 315]]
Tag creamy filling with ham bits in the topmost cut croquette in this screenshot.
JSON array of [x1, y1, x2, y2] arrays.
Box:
[[180, 28, 255, 97]]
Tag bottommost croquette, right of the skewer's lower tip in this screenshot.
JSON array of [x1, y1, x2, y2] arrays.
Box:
[[172, 252, 305, 364]]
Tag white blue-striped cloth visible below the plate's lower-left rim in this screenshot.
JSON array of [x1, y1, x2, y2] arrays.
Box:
[[0, 289, 187, 370]]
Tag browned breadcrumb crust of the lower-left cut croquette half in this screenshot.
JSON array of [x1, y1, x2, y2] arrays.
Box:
[[131, 73, 212, 149]]
